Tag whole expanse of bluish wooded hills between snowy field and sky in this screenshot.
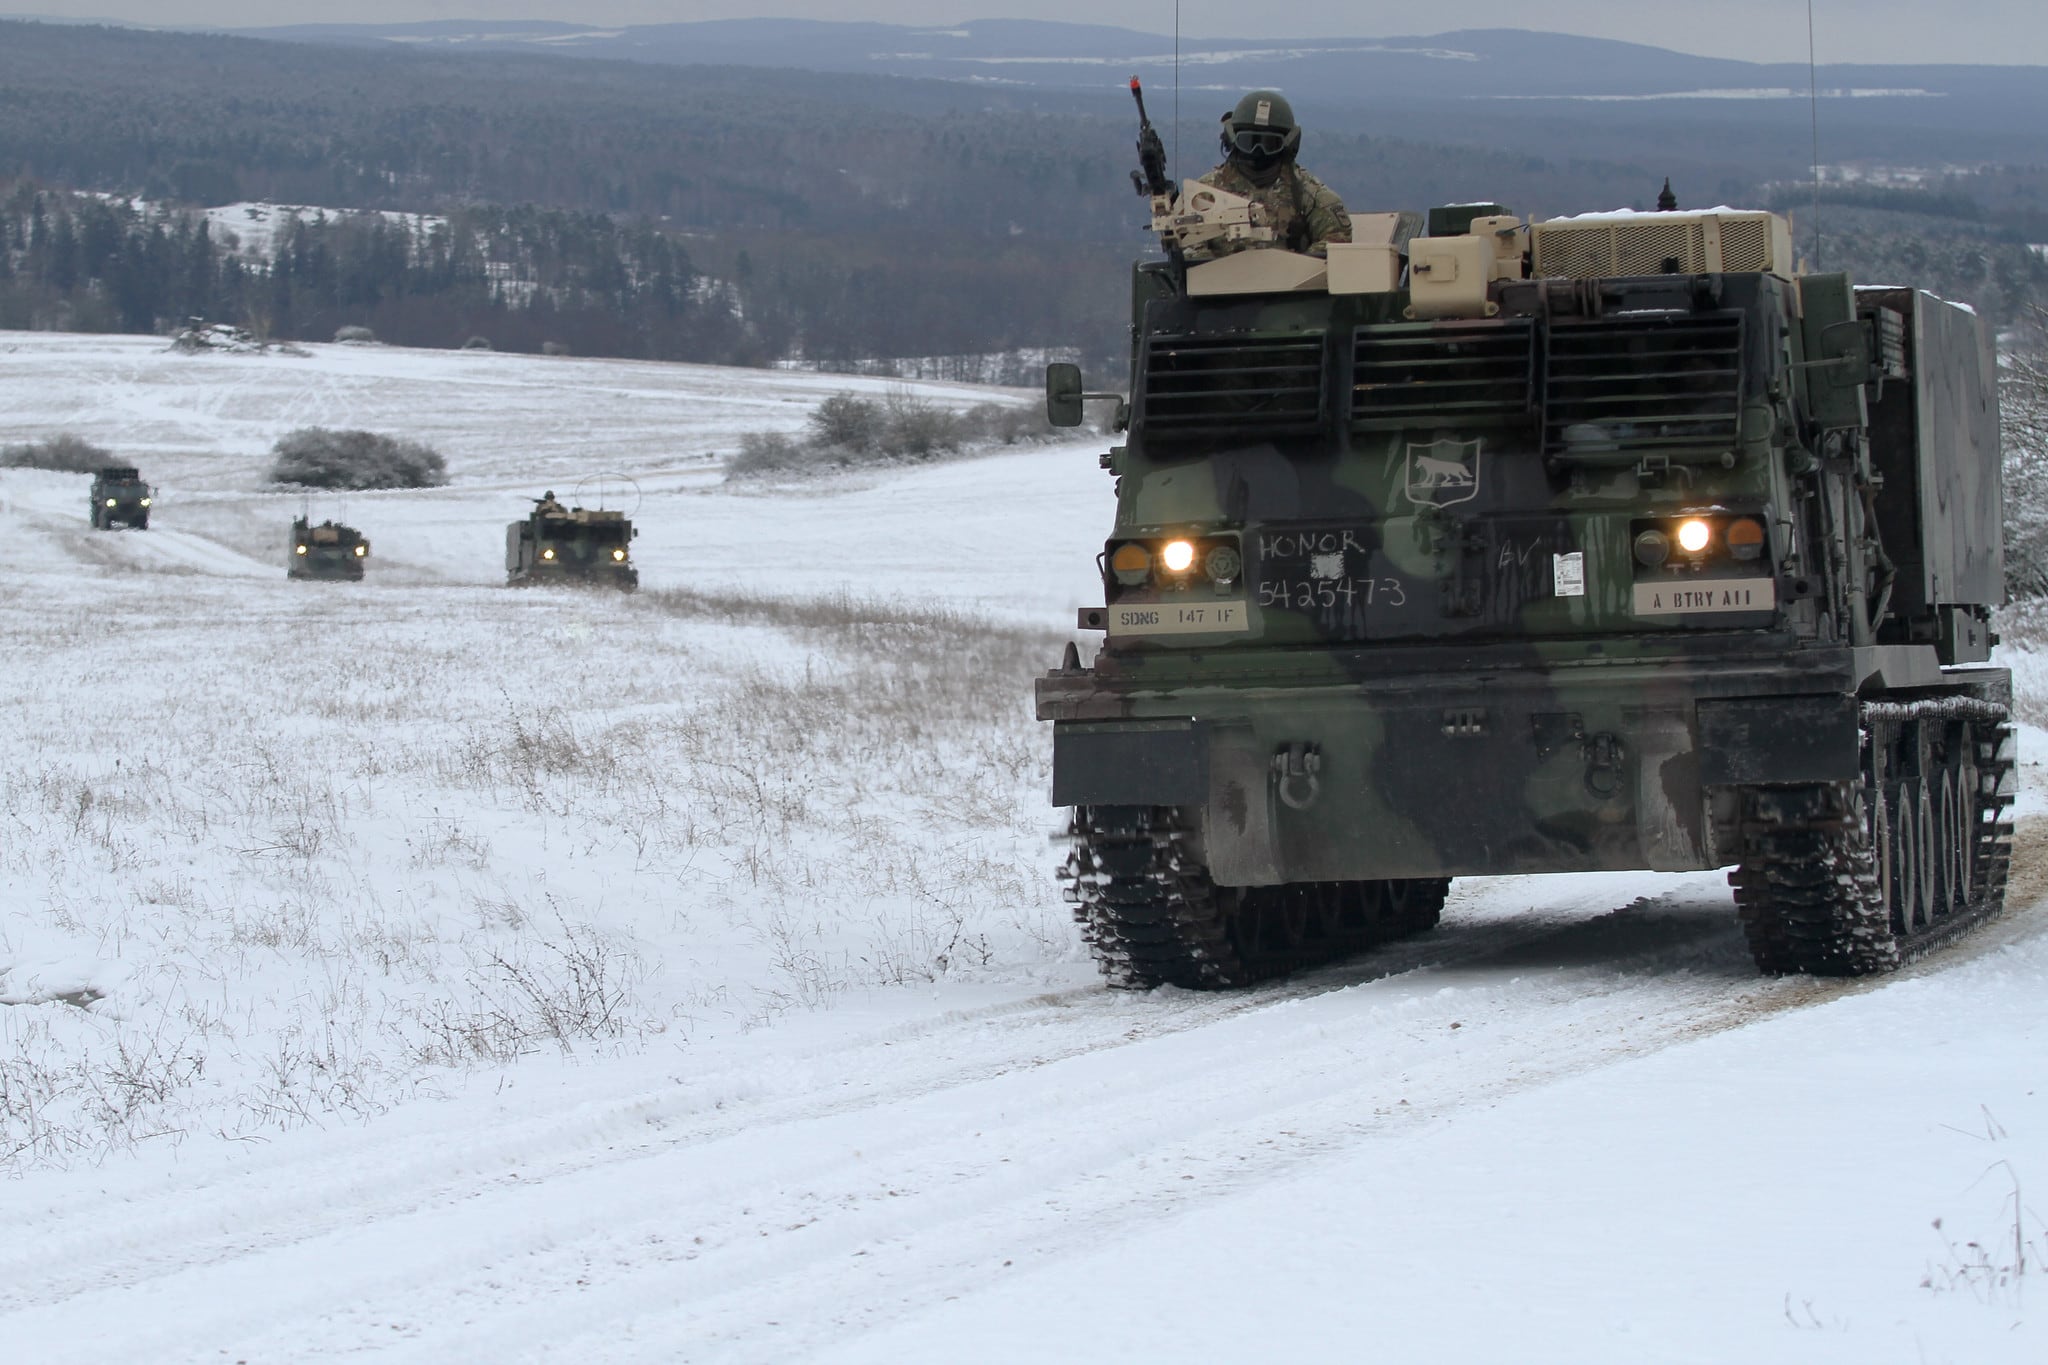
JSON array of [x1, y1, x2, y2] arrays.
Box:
[[0, 20, 2048, 368]]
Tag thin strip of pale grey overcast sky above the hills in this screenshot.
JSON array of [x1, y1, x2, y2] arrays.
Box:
[[0, 0, 2048, 65]]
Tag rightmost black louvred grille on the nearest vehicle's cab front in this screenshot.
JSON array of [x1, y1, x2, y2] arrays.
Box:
[[1544, 313, 1743, 458]]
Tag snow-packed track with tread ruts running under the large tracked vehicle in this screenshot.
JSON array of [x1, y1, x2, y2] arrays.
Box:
[[0, 839, 2048, 1361]]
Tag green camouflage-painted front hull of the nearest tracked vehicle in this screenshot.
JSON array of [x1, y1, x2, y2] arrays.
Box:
[[1038, 266, 1997, 886]]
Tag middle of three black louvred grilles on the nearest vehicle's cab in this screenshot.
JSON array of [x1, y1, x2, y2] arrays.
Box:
[[1352, 319, 1536, 428]]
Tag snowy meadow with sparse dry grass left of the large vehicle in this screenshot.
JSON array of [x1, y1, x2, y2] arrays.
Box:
[[0, 579, 1075, 1166]]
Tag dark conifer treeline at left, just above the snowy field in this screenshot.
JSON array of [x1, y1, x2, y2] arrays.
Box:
[[0, 186, 741, 360]]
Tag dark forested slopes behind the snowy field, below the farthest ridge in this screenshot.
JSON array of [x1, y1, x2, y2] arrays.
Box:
[[0, 23, 2048, 370]]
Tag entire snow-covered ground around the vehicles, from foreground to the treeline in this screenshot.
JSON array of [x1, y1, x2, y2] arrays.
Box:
[[0, 334, 2048, 1363]]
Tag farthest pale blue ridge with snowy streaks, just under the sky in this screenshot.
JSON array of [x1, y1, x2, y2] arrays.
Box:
[[232, 18, 2048, 176]]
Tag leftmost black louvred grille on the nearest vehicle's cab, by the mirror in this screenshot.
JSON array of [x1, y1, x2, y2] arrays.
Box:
[[1145, 332, 1323, 432]]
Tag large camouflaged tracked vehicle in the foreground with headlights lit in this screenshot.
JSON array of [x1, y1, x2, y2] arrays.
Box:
[[1036, 82, 2013, 988]]
